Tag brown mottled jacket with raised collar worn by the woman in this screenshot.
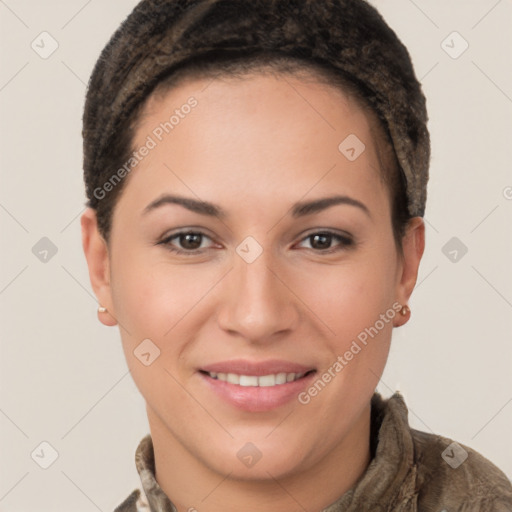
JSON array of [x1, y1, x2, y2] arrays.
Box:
[[114, 392, 512, 512]]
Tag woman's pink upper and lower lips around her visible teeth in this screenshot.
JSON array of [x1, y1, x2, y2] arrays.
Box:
[[198, 360, 316, 412]]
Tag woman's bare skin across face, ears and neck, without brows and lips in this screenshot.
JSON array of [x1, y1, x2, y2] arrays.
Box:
[[81, 74, 425, 512]]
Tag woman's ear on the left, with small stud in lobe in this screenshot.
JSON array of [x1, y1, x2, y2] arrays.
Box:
[[80, 208, 117, 326]]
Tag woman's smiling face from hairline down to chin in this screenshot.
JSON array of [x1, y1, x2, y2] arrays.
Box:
[[84, 74, 423, 479]]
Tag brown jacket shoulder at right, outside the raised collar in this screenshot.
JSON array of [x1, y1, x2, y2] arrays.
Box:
[[411, 429, 512, 512]]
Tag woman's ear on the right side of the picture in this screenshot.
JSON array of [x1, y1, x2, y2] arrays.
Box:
[[394, 217, 425, 327]]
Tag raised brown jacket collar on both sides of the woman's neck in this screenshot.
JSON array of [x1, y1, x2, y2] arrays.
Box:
[[135, 392, 416, 512]]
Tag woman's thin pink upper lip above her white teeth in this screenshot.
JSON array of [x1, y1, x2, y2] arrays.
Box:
[[199, 359, 315, 377]]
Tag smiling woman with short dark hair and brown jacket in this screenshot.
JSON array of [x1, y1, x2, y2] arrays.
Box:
[[82, 0, 512, 512]]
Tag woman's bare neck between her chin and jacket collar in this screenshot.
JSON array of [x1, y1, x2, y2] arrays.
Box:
[[147, 404, 371, 512]]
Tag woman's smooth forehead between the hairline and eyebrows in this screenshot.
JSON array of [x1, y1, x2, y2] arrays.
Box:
[[124, 73, 388, 215]]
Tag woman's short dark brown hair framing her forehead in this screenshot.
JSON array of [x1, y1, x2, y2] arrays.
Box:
[[83, 0, 430, 247]]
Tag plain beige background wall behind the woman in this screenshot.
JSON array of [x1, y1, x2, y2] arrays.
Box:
[[0, 0, 512, 512]]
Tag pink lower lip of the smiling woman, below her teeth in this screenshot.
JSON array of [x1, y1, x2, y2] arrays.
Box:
[[199, 372, 316, 412]]
